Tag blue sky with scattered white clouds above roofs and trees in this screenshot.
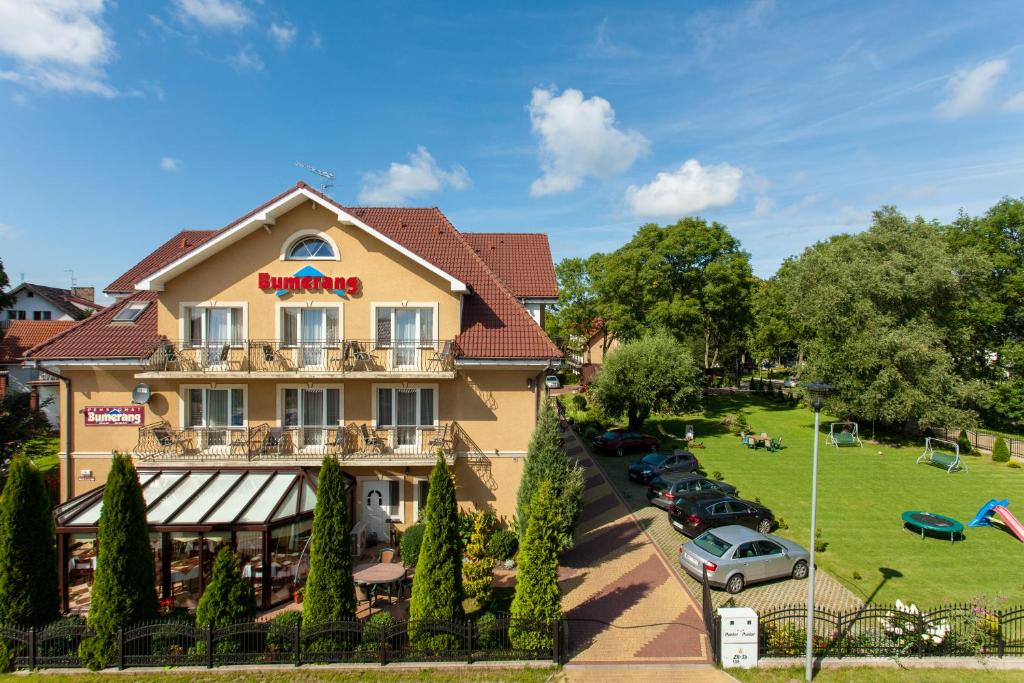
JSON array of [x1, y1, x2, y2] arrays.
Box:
[[0, 0, 1024, 301]]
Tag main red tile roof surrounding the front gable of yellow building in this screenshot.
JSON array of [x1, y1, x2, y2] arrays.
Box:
[[32, 182, 562, 358]]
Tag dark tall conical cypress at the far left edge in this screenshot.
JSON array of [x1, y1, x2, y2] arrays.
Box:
[[0, 456, 60, 626]]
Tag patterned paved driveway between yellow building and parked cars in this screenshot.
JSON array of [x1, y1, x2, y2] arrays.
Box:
[[560, 421, 731, 681]]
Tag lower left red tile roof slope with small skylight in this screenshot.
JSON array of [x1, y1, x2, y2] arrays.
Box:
[[26, 292, 158, 360]]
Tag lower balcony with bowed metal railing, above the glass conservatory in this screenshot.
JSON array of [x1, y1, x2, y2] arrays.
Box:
[[132, 422, 460, 465]]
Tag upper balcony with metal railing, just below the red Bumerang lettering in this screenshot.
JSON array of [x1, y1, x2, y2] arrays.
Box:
[[136, 339, 456, 379]]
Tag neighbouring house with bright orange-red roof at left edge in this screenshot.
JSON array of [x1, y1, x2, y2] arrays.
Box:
[[0, 321, 78, 429]]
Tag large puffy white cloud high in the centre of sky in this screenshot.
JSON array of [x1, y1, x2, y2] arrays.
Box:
[[528, 88, 649, 197]]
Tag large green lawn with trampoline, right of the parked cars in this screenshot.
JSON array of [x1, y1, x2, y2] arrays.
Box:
[[593, 394, 1024, 607]]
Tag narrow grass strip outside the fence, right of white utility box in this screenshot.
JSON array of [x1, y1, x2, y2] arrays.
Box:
[[729, 667, 1024, 683]]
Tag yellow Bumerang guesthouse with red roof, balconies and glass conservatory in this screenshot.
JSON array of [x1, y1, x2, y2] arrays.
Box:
[[27, 182, 560, 608]]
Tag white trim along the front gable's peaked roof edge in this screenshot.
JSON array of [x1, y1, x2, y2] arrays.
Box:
[[135, 187, 468, 292]]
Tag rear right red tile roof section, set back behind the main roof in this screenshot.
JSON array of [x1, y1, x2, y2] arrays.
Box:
[[462, 232, 558, 299]]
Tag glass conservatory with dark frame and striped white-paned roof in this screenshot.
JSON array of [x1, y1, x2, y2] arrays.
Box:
[[54, 467, 352, 612]]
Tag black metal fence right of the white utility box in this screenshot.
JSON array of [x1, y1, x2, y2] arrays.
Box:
[[759, 604, 1024, 657]]
